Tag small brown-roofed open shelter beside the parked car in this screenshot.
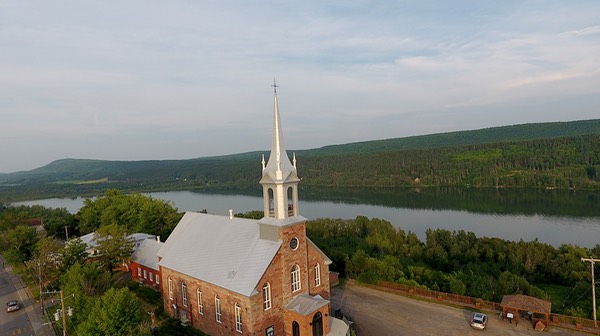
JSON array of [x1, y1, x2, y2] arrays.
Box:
[[500, 294, 552, 327]]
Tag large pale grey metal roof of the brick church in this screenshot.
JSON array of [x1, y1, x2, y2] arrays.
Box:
[[158, 212, 281, 296]]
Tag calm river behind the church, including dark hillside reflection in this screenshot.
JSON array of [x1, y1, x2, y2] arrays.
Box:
[[15, 188, 600, 248]]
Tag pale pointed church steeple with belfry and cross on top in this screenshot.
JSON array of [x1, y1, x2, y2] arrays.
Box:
[[260, 79, 300, 220]]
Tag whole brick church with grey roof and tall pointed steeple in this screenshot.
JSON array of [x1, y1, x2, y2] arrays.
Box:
[[157, 85, 349, 336]]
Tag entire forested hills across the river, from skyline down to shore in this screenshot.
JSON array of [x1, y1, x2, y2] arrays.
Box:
[[0, 119, 600, 194]]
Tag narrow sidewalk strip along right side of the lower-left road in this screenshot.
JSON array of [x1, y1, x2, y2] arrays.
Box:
[[0, 256, 56, 336]]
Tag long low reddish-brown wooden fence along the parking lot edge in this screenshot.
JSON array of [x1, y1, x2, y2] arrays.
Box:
[[377, 281, 600, 335]]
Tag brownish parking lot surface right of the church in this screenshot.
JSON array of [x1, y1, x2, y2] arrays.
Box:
[[331, 283, 584, 336]]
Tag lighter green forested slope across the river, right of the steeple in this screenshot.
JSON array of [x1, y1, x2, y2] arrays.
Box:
[[298, 135, 600, 189]]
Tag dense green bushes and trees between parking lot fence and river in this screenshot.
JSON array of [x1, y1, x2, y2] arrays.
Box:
[[307, 217, 600, 318]]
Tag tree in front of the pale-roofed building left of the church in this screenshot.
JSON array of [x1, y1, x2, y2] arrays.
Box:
[[96, 224, 134, 273]]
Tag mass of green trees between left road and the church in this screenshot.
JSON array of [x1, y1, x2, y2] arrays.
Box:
[[0, 190, 203, 336]]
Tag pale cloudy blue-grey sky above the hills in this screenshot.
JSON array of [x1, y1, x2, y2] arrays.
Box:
[[0, 0, 600, 173]]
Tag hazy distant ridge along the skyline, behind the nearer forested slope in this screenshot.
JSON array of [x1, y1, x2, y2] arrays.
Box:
[[0, 119, 600, 186]]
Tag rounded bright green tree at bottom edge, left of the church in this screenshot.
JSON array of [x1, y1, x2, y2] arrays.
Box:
[[77, 288, 144, 336]]
